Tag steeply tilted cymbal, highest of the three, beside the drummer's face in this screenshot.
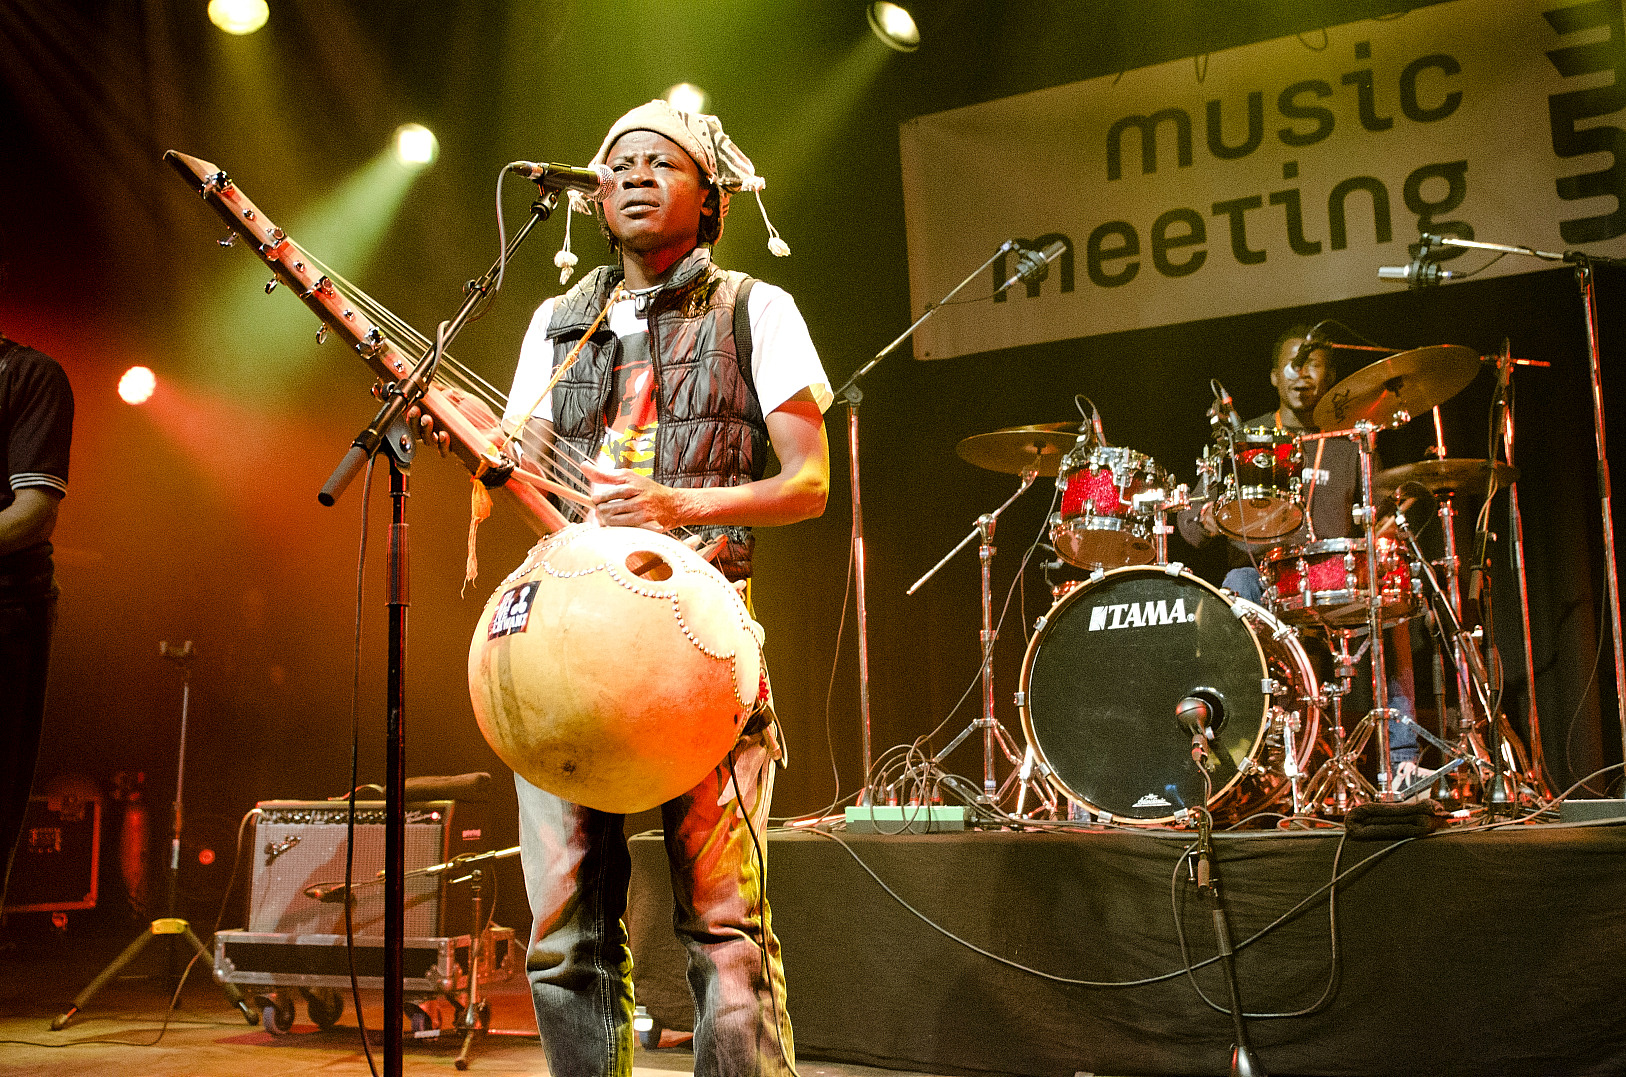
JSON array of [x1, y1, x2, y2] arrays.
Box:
[[1315, 343, 1480, 431]]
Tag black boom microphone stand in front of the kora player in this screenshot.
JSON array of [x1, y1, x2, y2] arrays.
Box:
[[317, 192, 558, 1077]]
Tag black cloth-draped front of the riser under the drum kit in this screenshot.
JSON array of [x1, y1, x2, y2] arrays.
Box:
[[629, 825, 1626, 1077]]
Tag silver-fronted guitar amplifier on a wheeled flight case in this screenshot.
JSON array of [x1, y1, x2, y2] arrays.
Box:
[[249, 800, 491, 937]]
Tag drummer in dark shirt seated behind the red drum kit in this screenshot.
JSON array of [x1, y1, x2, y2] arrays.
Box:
[[1176, 325, 1418, 787]]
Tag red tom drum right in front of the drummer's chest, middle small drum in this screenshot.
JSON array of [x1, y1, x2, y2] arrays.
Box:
[[1198, 429, 1304, 542]]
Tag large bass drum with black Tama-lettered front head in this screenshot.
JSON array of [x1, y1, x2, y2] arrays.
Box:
[[1018, 565, 1320, 823]]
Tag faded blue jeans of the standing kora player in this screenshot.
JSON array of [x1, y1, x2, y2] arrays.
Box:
[[514, 734, 795, 1077]]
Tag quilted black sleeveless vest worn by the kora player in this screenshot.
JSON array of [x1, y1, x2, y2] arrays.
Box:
[[548, 247, 767, 579]]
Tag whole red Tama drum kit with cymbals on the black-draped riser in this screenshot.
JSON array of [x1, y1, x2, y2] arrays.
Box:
[[936, 345, 1546, 825]]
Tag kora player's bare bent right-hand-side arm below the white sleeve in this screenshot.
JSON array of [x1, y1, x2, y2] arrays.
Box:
[[584, 389, 829, 530]]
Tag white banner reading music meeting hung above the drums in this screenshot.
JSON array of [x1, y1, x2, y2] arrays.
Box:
[[901, 0, 1626, 360]]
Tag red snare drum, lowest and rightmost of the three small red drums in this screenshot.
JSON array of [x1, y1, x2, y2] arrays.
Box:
[[1259, 537, 1418, 626]]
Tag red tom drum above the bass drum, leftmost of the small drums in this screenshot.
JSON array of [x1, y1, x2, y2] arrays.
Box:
[[1050, 438, 1167, 568]]
